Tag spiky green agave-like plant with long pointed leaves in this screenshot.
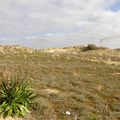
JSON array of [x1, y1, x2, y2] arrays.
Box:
[[0, 80, 36, 117]]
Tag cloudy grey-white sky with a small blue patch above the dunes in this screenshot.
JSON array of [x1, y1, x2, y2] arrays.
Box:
[[0, 0, 120, 48]]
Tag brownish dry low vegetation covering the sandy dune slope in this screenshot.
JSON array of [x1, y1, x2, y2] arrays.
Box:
[[0, 46, 120, 120]]
